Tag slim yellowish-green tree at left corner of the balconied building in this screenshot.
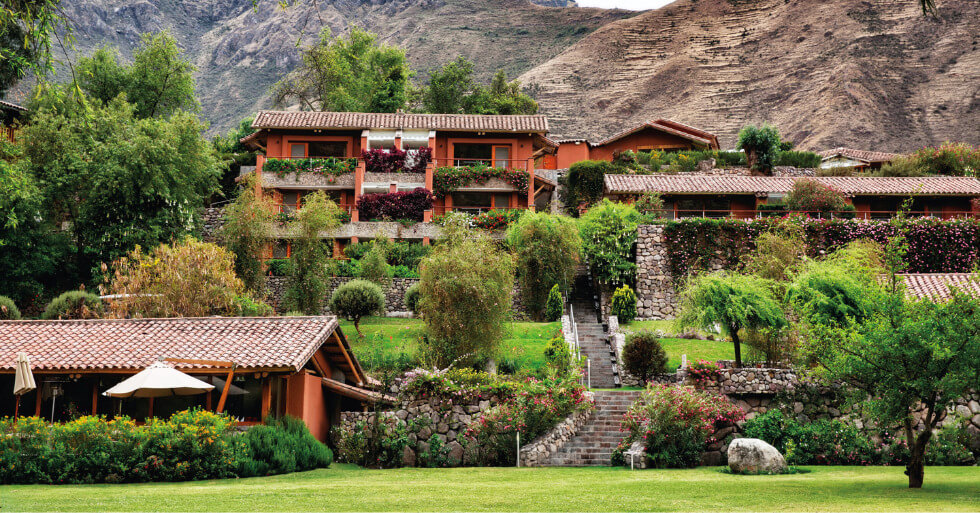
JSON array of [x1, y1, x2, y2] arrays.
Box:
[[220, 175, 275, 294]]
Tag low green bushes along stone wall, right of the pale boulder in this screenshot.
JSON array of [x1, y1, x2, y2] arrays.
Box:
[[743, 409, 976, 465]]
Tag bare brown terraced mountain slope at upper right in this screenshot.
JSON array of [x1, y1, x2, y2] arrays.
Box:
[[521, 0, 980, 151]]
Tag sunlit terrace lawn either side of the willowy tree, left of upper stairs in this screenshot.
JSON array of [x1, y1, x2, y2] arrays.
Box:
[[340, 317, 561, 369]]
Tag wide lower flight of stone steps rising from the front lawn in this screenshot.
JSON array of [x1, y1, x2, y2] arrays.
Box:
[[544, 390, 640, 467]]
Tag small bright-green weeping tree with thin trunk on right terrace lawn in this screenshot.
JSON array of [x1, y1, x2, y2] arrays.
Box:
[[679, 271, 786, 367]]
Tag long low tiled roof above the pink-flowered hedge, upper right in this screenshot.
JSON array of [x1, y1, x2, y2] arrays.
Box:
[[605, 174, 980, 196]]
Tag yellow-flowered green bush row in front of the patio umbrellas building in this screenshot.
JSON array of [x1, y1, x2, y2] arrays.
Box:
[[0, 409, 332, 484]]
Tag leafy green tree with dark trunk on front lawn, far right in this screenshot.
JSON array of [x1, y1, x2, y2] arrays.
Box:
[[797, 245, 980, 488]]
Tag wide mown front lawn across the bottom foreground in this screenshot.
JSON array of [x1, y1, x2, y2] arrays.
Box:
[[0, 465, 980, 512]]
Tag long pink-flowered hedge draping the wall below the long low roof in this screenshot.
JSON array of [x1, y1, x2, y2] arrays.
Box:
[[664, 216, 980, 279]]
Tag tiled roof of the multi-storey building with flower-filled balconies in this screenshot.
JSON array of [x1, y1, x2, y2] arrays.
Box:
[[252, 110, 548, 133]]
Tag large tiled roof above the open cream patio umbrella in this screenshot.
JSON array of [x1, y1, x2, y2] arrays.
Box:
[[0, 317, 357, 371]]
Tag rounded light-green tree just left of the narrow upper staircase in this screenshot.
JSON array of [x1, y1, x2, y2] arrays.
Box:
[[505, 212, 582, 318]]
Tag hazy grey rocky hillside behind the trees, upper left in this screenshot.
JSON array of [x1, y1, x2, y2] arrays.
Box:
[[55, 0, 635, 131]]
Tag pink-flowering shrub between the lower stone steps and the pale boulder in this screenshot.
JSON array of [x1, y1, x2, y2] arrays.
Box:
[[616, 385, 745, 468]]
